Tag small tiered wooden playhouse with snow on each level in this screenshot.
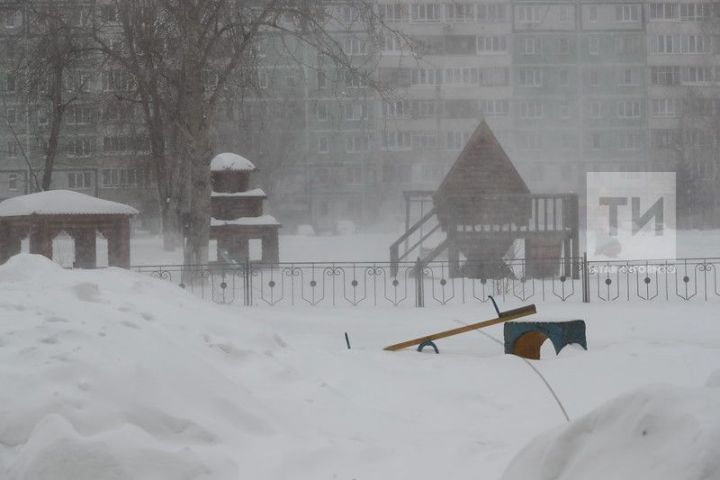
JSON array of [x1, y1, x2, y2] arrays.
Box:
[[210, 153, 281, 263]]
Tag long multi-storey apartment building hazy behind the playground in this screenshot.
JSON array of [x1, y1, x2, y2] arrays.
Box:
[[0, 0, 720, 230]]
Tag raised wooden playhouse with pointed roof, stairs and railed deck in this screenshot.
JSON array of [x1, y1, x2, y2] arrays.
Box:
[[390, 121, 579, 278]]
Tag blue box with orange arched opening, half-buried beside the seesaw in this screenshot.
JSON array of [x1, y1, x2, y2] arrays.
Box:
[[504, 320, 587, 360]]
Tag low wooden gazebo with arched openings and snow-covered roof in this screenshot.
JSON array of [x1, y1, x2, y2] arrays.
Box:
[[0, 190, 138, 268]]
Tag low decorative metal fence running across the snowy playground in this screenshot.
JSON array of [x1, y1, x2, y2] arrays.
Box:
[[133, 258, 720, 307]]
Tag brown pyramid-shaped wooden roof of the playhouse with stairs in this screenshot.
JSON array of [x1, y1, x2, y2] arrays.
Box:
[[434, 120, 530, 204]]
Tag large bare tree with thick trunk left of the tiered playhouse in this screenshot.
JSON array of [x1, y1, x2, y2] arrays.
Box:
[[94, 0, 394, 264]]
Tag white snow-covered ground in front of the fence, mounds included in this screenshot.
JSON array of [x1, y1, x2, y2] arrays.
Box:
[[0, 255, 720, 480]]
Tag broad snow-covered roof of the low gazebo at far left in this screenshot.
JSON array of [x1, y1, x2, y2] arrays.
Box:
[[0, 190, 138, 217]]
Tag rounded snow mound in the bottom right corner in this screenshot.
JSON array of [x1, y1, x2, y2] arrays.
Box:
[[503, 382, 720, 480]]
